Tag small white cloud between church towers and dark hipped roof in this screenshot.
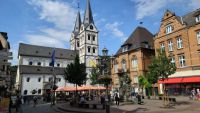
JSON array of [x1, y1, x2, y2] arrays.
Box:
[[105, 22, 125, 38]]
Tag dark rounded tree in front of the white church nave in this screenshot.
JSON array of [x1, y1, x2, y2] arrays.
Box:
[[64, 55, 87, 93]]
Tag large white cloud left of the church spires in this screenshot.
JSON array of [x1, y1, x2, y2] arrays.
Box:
[[26, 0, 77, 48]]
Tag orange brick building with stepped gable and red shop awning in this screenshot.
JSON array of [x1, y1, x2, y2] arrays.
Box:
[[154, 9, 200, 94]]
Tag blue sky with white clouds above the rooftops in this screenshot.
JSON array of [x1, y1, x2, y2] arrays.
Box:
[[0, 0, 200, 65]]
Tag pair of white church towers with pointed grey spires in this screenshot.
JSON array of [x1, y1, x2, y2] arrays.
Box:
[[70, 0, 99, 84]]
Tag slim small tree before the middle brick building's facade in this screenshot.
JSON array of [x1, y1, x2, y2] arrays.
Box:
[[119, 71, 131, 101]]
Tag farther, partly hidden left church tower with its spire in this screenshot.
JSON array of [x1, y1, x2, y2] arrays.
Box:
[[70, 11, 82, 50]]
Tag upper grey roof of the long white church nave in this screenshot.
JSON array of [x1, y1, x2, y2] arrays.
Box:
[[18, 43, 78, 60]]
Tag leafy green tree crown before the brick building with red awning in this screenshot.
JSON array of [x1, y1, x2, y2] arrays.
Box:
[[147, 50, 176, 84]]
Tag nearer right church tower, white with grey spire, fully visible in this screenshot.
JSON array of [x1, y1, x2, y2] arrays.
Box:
[[74, 0, 99, 84]]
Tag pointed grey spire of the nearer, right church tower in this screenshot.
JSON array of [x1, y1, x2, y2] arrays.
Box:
[[83, 0, 94, 26]]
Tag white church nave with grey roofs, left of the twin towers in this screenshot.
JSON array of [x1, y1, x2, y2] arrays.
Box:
[[16, 43, 78, 96]]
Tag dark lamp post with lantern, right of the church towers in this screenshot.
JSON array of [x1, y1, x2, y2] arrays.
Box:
[[97, 48, 112, 113]]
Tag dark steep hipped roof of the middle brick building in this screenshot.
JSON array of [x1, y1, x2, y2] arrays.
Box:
[[116, 26, 153, 55]]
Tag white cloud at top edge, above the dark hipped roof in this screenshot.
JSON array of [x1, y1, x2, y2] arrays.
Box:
[[131, 0, 167, 20]]
